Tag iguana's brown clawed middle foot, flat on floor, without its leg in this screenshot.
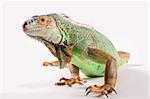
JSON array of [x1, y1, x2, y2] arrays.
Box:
[[55, 77, 86, 87]]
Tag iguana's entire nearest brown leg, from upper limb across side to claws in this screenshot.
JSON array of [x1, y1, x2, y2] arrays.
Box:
[[86, 48, 117, 97]]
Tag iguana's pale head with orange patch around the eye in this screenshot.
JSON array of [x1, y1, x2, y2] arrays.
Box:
[[23, 15, 62, 43]]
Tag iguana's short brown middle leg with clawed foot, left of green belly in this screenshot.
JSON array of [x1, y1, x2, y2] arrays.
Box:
[[56, 64, 86, 87]]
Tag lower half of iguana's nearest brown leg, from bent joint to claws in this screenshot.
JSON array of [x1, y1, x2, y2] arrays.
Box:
[[86, 59, 117, 97]]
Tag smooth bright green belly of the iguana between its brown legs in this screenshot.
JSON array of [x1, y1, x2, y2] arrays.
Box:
[[72, 55, 105, 77]]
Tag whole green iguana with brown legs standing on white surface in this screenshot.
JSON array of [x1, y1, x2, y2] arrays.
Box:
[[23, 13, 130, 97]]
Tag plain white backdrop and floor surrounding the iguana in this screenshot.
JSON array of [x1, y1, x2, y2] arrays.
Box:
[[0, 1, 148, 99]]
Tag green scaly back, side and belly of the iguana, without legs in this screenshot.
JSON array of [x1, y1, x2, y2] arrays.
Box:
[[50, 14, 125, 76]]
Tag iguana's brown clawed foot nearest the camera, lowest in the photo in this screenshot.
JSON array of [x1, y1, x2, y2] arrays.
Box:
[[86, 84, 117, 97]]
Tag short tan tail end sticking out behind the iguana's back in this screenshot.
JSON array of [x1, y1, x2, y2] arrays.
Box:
[[118, 51, 130, 65]]
